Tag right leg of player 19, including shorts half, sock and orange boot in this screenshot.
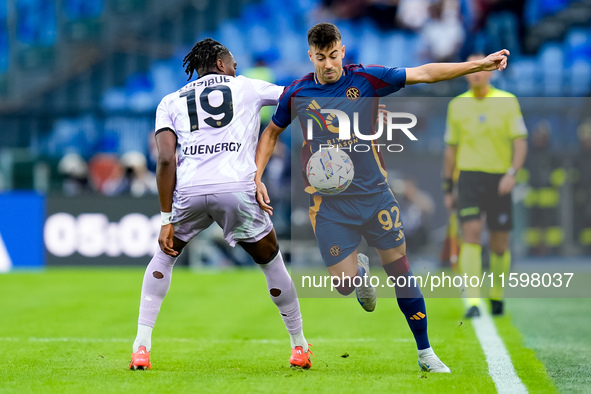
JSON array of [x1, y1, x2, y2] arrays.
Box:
[[213, 192, 312, 369]]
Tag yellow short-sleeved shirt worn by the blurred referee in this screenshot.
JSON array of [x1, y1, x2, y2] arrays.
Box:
[[445, 86, 527, 174]]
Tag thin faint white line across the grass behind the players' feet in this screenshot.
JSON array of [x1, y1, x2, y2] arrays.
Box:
[[0, 337, 414, 344]]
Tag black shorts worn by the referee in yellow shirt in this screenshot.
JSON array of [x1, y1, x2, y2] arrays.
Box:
[[458, 171, 513, 231]]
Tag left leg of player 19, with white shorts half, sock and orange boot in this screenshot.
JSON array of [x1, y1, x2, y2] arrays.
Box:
[[129, 196, 213, 369]]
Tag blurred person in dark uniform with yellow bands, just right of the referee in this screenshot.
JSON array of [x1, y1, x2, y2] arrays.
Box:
[[524, 120, 566, 256]]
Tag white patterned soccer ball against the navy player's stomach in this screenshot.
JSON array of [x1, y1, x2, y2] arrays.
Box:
[[306, 148, 355, 194]]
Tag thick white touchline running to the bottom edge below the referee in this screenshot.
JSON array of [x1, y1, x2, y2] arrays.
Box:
[[470, 306, 527, 394]]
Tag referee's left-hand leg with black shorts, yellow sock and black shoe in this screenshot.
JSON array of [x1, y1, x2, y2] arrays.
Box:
[[458, 171, 486, 318]]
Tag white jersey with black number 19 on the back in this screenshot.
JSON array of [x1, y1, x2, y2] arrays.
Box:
[[156, 74, 283, 196]]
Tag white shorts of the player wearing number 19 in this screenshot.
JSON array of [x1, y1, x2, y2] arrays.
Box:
[[172, 191, 273, 247]]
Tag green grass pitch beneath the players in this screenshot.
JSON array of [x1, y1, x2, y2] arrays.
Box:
[[0, 269, 591, 393]]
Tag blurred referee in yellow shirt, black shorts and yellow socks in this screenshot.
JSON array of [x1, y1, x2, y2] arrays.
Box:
[[443, 54, 527, 318]]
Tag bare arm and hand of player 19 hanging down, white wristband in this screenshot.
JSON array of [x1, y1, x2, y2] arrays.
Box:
[[156, 131, 179, 256]]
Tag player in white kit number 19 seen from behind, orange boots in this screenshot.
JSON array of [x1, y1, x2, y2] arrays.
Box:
[[129, 38, 312, 369]]
